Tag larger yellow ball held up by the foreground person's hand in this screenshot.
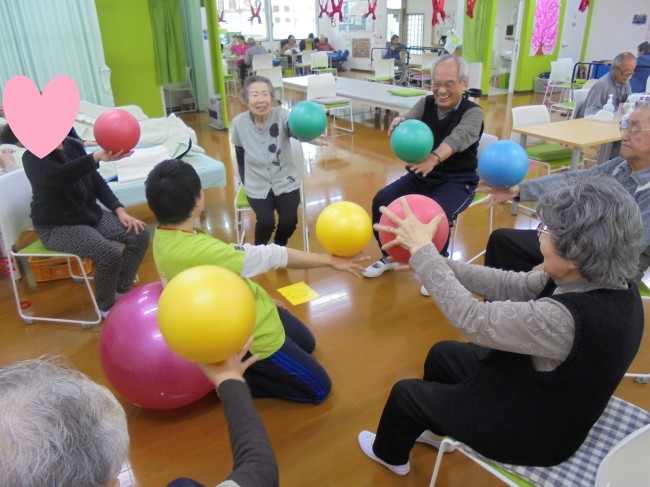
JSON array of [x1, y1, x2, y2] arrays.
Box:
[[158, 265, 255, 363]]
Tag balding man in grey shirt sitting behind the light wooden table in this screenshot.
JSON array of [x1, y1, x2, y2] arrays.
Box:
[[576, 52, 636, 118]]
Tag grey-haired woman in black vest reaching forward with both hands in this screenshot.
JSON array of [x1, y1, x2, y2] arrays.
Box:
[[359, 176, 643, 475]]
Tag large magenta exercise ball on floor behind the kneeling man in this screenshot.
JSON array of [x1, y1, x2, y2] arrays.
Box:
[[99, 282, 214, 409]]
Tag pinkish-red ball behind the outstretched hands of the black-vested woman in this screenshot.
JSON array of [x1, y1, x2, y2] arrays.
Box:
[[379, 194, 449, 264]]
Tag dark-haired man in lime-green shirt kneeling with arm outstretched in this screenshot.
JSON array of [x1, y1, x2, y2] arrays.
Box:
[[145, 160, 364, 404]]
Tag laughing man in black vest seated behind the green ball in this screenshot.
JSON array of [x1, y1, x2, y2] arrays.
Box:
[[363, 54, 483, 277]]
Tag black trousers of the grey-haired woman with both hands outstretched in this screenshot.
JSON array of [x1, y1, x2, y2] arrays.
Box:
[[373, 341, 490, 465]]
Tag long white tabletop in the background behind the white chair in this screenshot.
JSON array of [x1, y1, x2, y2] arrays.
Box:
[[282, 76, 425, 114]]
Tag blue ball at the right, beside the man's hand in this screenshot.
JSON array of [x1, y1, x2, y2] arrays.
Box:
[[478, 140, 528, 188]]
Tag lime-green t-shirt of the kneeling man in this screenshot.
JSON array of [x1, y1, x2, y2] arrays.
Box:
[[153, 228, 285, 358]]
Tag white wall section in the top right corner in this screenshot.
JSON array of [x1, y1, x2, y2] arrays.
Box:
[[584, 0, 650, 61]]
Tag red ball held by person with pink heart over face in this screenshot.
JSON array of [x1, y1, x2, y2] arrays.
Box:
[[93, 108, 140, 152]]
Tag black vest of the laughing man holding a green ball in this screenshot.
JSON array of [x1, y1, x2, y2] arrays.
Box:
[[422, 95, 483, 178]]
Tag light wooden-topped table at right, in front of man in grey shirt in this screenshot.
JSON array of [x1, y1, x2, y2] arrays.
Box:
[[512, 118, 621, 171]]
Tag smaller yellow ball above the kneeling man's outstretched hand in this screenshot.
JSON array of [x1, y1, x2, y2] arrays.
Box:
[[316, 201, 372, 257]]
